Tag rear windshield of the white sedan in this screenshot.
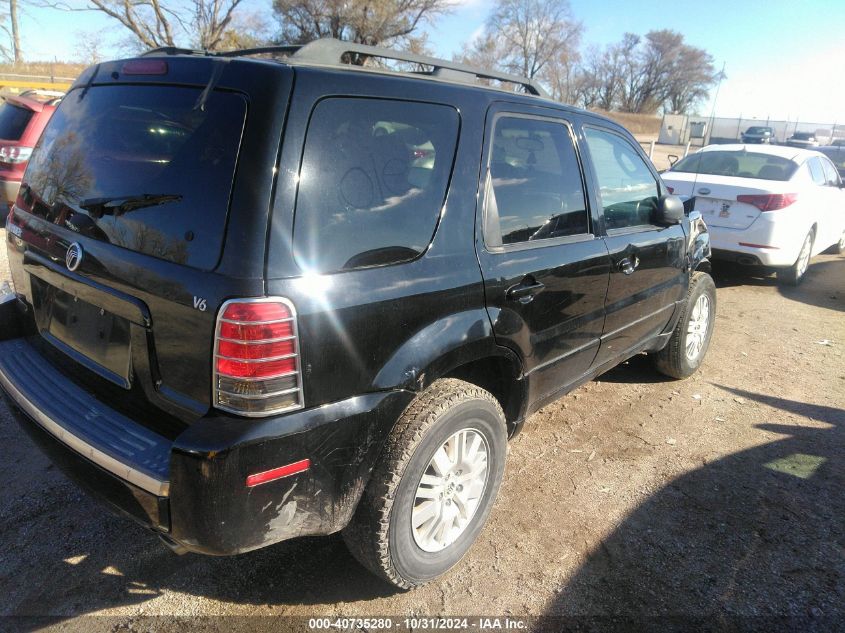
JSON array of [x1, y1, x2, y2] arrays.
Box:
[[669, 151, 798, 180]]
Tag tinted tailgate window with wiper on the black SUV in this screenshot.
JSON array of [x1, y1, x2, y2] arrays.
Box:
[[19, 86, 246, 270]]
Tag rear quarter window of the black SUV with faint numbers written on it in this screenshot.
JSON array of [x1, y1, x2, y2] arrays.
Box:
[[293, 98, 458, 273]]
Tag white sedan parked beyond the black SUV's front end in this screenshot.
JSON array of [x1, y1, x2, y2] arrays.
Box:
[[663, 145, 845, 284]]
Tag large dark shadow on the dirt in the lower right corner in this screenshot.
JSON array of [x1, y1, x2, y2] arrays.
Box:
[[547, 385, 845, 631]]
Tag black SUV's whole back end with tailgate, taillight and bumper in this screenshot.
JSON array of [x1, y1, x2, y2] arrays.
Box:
[[0, 56, 416, 554]]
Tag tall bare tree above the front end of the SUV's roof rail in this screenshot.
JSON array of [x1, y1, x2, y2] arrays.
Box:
[[460, 0, 583, 84]]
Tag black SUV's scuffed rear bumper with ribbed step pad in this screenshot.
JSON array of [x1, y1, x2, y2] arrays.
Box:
[[0, 312, 413, 555]]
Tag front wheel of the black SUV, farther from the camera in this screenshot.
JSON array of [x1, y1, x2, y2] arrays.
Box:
[[652, 272, 716, 379]]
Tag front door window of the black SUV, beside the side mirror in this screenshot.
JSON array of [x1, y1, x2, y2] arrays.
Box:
[[584, 128, 658, 229]]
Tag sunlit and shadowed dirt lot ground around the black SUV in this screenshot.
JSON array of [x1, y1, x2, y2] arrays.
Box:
[[0, 232, 845, 631]]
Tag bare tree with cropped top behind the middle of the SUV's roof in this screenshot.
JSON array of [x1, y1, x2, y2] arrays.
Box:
[[273, 0, 451, 48]]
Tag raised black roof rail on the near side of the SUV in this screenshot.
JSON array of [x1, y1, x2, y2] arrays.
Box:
[[211, 38, 549, 97]]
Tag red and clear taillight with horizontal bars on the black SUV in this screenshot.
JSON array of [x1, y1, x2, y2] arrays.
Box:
[[214, 298, 303, 416]]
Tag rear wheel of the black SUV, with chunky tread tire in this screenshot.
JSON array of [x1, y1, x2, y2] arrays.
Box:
[[343, 378, 507, 589]]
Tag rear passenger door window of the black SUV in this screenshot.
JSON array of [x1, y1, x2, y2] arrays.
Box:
[[487, 117, 589, 244]]
